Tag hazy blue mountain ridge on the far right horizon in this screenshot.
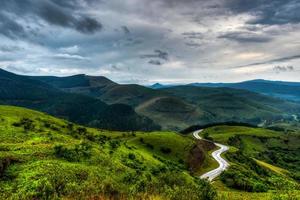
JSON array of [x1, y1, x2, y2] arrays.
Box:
[[189, 79, 300, 102]]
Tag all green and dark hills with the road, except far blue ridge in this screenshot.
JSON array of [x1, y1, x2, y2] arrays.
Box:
[[0, 70, 300, 200]]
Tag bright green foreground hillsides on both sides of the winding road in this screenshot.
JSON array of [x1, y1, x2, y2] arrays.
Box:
[[0, 106, 300, 200]]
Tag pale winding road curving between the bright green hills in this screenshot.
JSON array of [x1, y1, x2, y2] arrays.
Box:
[[193, 130, 229, 181]]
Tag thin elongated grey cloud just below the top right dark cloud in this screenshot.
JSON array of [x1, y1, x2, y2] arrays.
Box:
[[219, 31, 272, 43]]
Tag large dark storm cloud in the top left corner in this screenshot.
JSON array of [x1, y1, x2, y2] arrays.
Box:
[[0, 0, 102, 38]]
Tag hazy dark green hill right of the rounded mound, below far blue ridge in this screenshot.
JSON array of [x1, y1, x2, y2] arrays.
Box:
[[161, 86, 300, 124]]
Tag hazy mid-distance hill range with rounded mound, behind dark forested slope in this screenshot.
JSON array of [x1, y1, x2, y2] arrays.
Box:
[[33, 72, 300, 130]]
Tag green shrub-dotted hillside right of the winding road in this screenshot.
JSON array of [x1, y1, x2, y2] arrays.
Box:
[[202, 126, 300, 199]]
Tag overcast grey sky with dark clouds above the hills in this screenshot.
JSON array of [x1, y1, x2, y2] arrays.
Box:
[[0, 0, 300, 84]]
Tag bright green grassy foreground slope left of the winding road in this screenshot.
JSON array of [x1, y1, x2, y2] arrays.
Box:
[[0, 106, 214, 199]]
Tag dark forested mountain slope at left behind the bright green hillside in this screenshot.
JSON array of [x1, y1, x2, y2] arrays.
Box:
[[0, 69, 159, 130]]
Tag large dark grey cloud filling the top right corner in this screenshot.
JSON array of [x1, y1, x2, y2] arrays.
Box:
[[225, 0, 300, 25]]
